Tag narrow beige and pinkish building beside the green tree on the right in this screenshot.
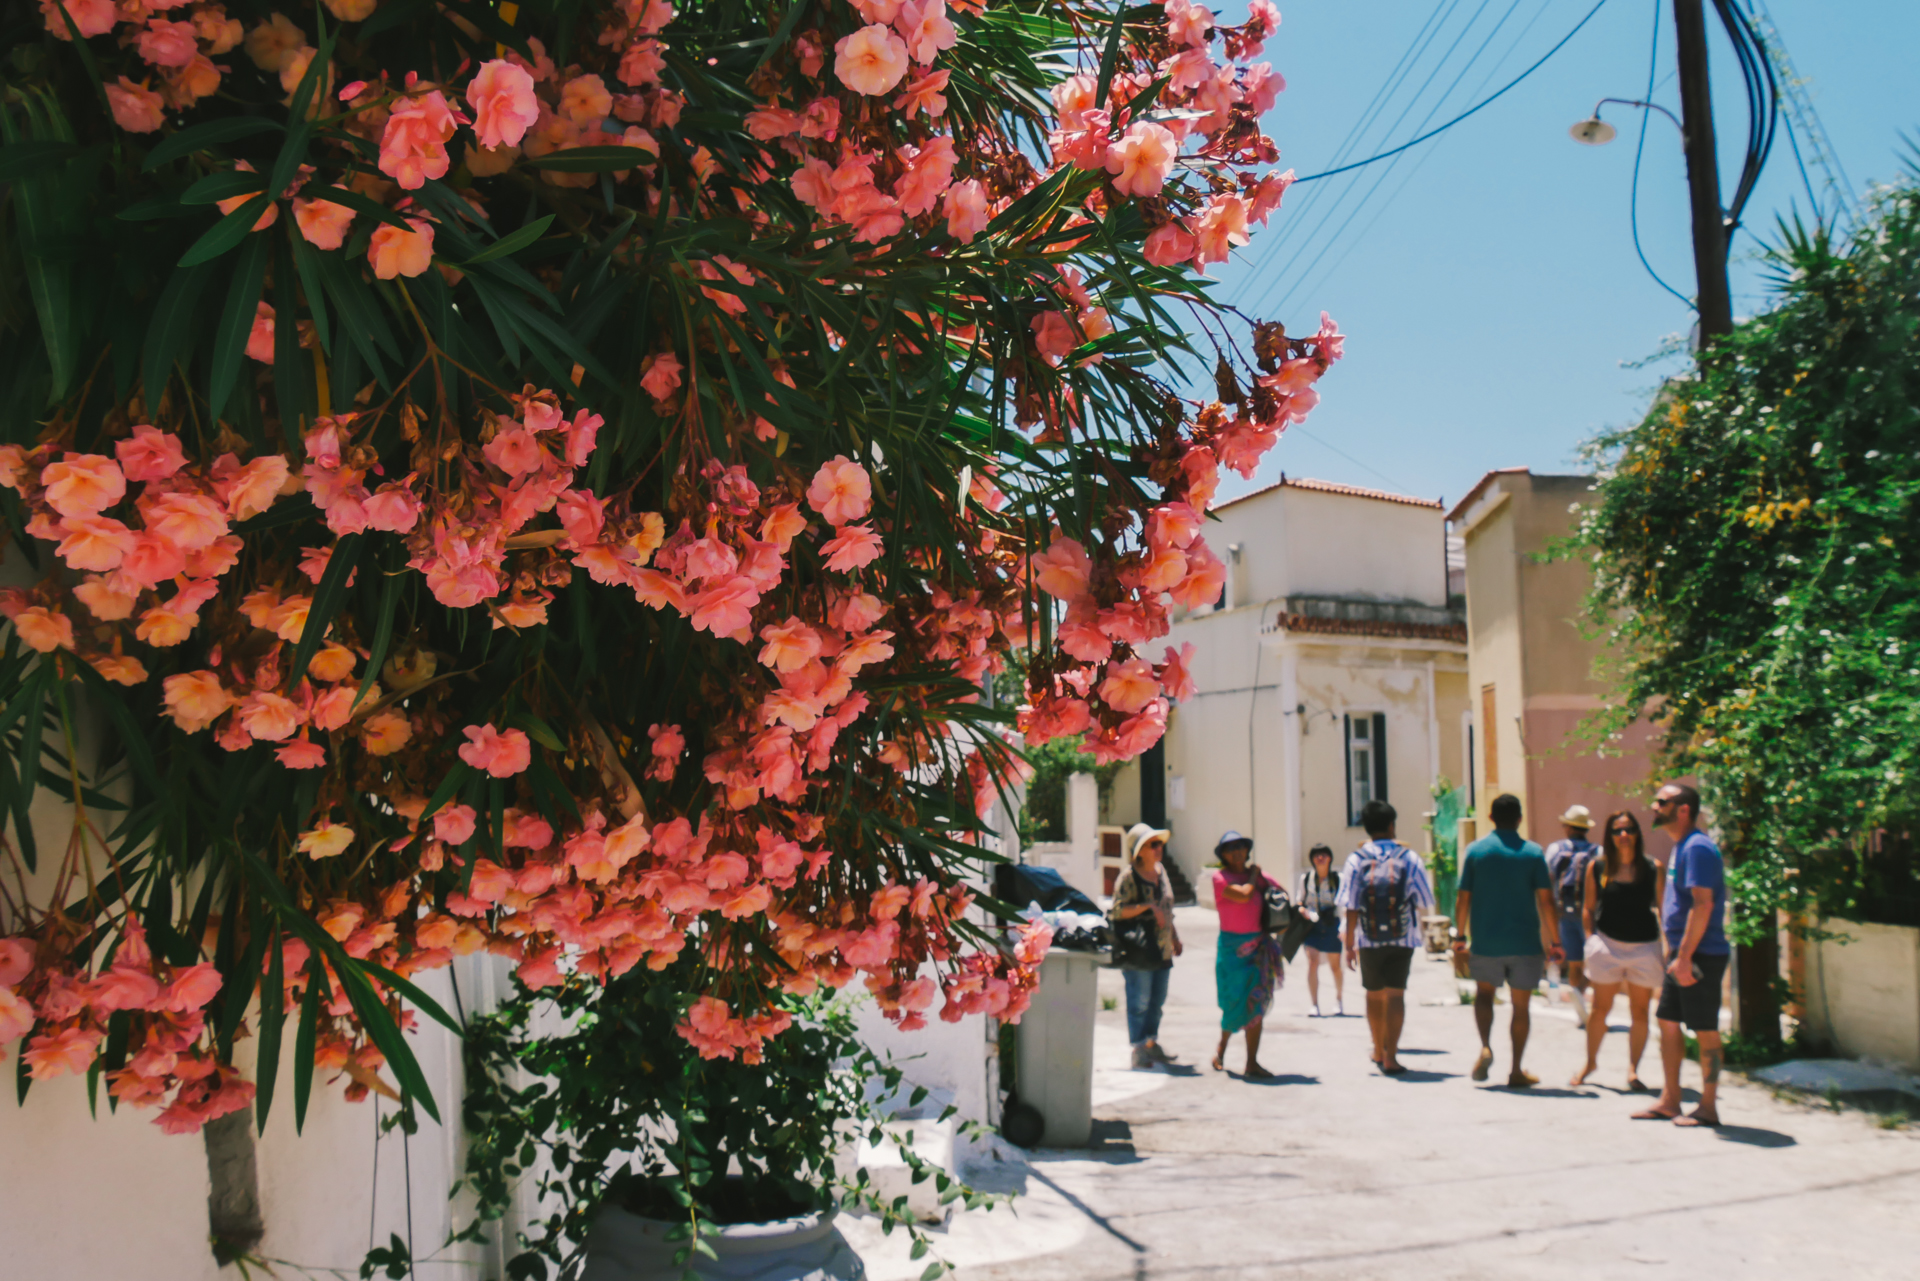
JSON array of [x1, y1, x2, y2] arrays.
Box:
[[1448, 467, 1651, 843]]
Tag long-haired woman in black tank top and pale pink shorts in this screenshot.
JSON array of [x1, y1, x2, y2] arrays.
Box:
[[1572, 810, 1665, 1093]]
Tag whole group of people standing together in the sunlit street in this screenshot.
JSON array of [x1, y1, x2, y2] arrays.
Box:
[[1112, 784, 1730, 1125]]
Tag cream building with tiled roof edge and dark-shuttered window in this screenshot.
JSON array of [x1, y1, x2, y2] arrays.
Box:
[[1110, 476, 1467, 901]]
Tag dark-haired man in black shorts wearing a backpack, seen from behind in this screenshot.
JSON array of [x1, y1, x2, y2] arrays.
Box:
[[1340, 801, 1434, 1076]]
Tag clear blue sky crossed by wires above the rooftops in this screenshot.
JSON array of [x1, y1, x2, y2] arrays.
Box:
[[1213, 0, 1920, 503]]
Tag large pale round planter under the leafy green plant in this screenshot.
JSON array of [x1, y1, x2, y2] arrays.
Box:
[[580, 1208, 866, 1281]]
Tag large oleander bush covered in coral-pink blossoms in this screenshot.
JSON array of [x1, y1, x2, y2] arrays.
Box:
[[0, 0, 1342, 1129]]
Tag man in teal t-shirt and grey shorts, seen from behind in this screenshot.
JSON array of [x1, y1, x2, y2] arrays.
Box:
[[1453, 795, 1565, 1089]]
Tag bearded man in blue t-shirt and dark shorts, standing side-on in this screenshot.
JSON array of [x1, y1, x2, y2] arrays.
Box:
[[1634, 784, 1732, 1125]]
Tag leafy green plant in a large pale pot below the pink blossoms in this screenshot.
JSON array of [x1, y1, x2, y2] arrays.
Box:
[[426, 962, 989, 1281]]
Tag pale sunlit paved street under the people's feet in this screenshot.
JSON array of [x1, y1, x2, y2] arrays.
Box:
[[856, 908, 1920, 1281]]
